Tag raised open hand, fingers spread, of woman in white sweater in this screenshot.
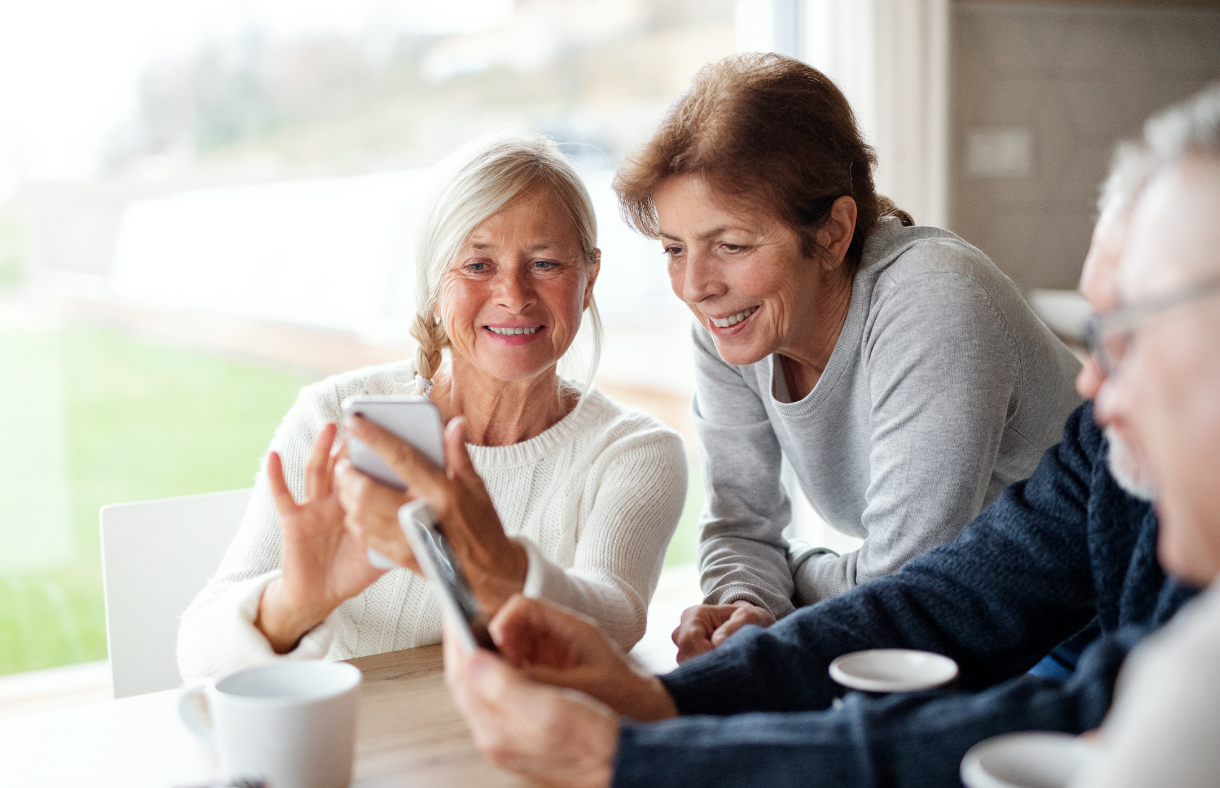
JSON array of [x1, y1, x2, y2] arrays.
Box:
[[254, 424, 383, 654]]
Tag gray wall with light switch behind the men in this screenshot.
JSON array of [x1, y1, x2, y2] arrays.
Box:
[[949, 2, 1220, 289]]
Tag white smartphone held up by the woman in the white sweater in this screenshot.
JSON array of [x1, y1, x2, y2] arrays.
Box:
[[343, 394, 445, 570]]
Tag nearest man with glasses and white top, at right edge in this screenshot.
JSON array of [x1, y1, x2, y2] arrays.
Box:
[[1080, 84, 1220, 788]]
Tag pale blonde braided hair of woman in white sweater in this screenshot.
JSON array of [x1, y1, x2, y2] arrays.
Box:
[[411, 123, 603, 403]]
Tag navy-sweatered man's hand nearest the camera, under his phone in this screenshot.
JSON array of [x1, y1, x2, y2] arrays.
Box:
[[444, 625, 620, 788]]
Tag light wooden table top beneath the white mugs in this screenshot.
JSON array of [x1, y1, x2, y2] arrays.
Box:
[[0, 604, 681, 788]]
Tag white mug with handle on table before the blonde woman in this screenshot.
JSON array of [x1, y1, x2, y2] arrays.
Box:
[[178, 662, 361, 788]]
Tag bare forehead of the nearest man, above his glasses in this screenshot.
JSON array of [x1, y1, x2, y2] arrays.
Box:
[[1119, 156, 1220, 303]]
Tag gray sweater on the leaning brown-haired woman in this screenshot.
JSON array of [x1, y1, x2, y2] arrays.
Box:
[[692, 218, 1080, 617]]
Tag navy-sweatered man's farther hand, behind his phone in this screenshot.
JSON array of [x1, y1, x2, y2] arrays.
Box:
[[488, 595, 677, 722]]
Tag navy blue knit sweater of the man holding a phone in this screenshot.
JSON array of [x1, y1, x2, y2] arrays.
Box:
[[614, 403, 1194, 788]]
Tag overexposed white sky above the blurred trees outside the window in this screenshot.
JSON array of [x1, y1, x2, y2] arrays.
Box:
[[0, 0, 514, 202]]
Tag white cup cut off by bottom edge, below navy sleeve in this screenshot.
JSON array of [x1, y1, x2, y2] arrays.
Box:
[[961, 731, 1094, 788]]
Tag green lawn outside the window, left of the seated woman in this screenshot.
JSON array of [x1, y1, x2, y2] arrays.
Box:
[[0, 328, 310, 673]]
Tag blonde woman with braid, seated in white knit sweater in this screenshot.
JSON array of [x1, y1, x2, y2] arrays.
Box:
[[178, 129, 686, 678]]
